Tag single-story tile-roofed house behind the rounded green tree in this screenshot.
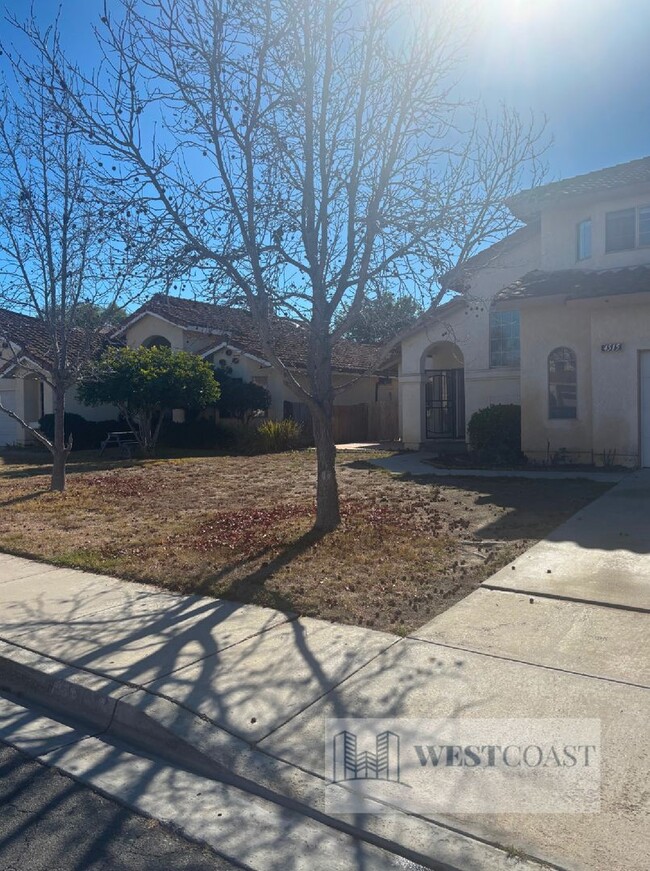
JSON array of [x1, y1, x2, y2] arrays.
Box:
[[112, 294, 398, 442]]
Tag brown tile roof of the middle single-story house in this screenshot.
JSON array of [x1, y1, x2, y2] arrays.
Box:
[[113, 293, 394, 374]]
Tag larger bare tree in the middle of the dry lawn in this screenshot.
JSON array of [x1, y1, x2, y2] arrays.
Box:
[[24, 0, 541, 530]]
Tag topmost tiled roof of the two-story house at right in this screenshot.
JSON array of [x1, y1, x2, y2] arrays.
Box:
[[506, 157, 650, 223]]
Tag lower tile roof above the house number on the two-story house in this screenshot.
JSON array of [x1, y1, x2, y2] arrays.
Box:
[[494, 265, 650, 302]]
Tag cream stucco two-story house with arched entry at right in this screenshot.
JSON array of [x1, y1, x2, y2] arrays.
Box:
[[399, 158, 650, 466]]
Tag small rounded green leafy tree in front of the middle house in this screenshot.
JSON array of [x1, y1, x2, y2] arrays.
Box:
[[78, 347, 220, 454]]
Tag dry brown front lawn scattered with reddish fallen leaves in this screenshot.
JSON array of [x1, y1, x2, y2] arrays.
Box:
[[0, 451, 607, 633]]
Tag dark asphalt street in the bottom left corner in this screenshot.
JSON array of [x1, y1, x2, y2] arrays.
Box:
[[0, 743, 236, 871]]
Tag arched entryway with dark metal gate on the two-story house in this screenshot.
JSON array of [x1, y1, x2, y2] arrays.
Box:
[[421, 342, 465, 442]]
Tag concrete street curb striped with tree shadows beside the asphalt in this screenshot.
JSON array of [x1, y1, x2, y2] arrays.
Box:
[[0, 640, 563, 871]]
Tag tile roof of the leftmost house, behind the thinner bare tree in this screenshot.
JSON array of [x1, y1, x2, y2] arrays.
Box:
[[0, 309, 104, 373]]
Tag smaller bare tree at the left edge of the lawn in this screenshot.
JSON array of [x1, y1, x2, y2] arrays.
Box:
[[0, 30, 157, 490]]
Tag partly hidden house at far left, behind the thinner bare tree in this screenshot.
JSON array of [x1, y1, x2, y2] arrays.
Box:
[[0, 309, 117, 446]]
